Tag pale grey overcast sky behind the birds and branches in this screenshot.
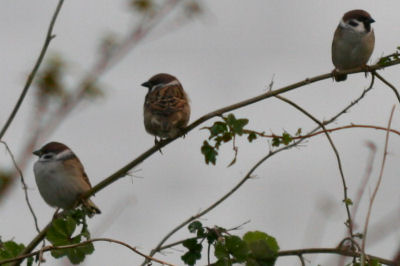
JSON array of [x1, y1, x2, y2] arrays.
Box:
[[0, 0, 400, 266]]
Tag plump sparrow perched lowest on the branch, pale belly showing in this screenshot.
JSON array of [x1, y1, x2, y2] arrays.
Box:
[[33, 142, 101, 214]]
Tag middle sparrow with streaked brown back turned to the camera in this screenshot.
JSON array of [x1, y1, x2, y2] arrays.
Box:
[[142, 73, 190, 143]]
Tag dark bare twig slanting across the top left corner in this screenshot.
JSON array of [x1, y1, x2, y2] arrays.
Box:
[[0, 0, 64, 140]]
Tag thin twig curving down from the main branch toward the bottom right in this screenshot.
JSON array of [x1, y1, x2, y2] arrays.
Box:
[[276, 95, 353, 237]]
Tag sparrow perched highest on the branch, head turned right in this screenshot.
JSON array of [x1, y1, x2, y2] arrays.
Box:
[[332, 9, 375, 81]]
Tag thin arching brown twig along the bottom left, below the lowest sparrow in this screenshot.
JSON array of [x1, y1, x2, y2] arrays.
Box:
[[0, 237, 174, 266]]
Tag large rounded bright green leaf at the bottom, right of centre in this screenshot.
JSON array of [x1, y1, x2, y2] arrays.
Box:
[[243, 231, 279, 265]]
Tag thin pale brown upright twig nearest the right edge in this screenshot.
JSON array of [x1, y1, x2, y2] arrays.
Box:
[[361, 106, 396, 265]]
